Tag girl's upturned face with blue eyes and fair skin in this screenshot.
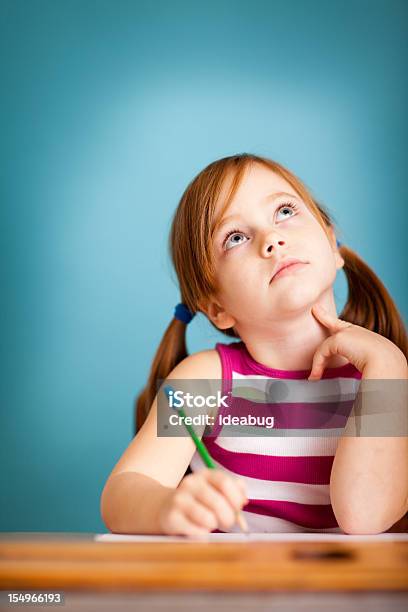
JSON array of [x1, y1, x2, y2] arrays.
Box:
[[208, 164, 344, 330]]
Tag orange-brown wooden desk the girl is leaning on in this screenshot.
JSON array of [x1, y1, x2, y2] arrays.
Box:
[[0, 532, 408, 612]]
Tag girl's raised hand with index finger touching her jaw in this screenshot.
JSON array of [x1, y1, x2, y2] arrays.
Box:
[[308, 304, 406, 380]]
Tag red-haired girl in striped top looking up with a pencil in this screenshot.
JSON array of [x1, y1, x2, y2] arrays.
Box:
[[101, 153, 408, 535]]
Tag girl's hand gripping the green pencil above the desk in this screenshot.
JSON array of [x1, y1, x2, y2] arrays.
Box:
[[159, 468, 248, 535]]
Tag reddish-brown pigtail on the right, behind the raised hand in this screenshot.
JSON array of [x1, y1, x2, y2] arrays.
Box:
[[339, 244, 408, 358]]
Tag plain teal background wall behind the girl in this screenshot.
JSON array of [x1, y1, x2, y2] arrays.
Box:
[[0, 0, 408, 531]]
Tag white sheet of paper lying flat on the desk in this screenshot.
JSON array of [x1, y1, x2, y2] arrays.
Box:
[[94, 533, 408, 543]]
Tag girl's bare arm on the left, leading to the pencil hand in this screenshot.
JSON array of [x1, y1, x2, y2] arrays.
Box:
[[100, 351, 226, 533]]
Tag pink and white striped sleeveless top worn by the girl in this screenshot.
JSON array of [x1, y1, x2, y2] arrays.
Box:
[[190, 341, 361, 533]]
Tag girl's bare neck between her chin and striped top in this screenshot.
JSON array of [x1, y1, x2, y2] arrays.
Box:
[[236, 295, 348, 370]]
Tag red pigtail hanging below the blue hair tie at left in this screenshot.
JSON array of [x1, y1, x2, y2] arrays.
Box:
[[134, 317, 187, 434]]
